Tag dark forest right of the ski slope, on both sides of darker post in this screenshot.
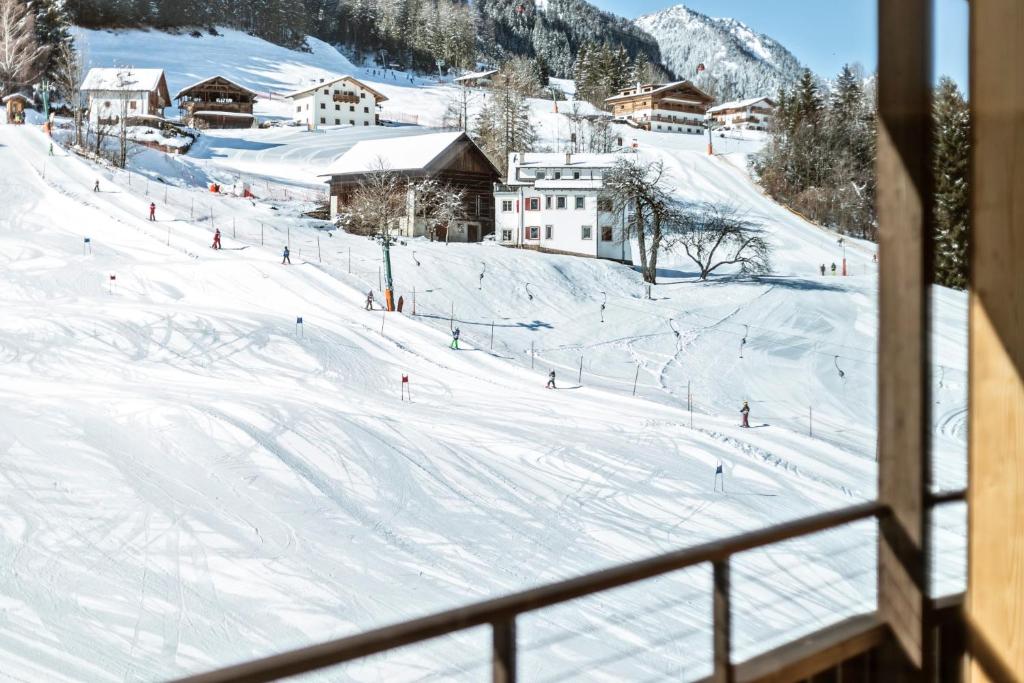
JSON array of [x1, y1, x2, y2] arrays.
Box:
[[752, 66, 971, 289]]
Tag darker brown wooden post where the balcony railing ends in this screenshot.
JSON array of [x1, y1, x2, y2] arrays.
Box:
[[878, 0, 934, 681]]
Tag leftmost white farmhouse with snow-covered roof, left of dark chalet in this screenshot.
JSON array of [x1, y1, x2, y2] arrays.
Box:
[[79, 67, 171, 126]]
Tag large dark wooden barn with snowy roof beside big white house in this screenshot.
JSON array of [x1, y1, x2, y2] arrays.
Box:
[[323, 131, 502, 242]]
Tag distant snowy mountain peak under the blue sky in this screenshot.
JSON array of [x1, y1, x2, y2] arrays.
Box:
[[636, 5, 802, 101]]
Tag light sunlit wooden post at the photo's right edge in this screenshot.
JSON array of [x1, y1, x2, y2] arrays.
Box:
[[966, 0, 1024, 683]]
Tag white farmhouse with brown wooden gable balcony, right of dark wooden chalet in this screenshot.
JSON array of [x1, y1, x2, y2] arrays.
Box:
[[286, 76, 387, 128]]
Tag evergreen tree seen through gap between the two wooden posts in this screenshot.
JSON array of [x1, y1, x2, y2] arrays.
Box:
[[933, 77, 971, 289]]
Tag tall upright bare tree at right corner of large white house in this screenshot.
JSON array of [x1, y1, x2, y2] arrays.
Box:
[[604, 157, 676, 285]]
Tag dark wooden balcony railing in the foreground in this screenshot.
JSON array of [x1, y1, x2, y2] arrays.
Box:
[[172, 492, 964, 683]]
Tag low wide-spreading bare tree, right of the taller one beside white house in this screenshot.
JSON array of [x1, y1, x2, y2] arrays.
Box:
[[669, 203, 771, 280]]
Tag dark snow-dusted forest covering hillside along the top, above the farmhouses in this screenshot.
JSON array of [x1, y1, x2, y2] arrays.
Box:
[[68, 0, 662, 77]]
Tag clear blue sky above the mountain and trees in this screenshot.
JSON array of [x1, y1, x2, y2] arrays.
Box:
[[591, 0, 968, 88]]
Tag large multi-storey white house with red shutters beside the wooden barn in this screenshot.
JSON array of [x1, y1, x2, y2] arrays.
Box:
[[495, 153, 632, 263]]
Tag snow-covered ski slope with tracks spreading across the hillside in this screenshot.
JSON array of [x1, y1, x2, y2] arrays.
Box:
[[0, 32, 966, 681]]
